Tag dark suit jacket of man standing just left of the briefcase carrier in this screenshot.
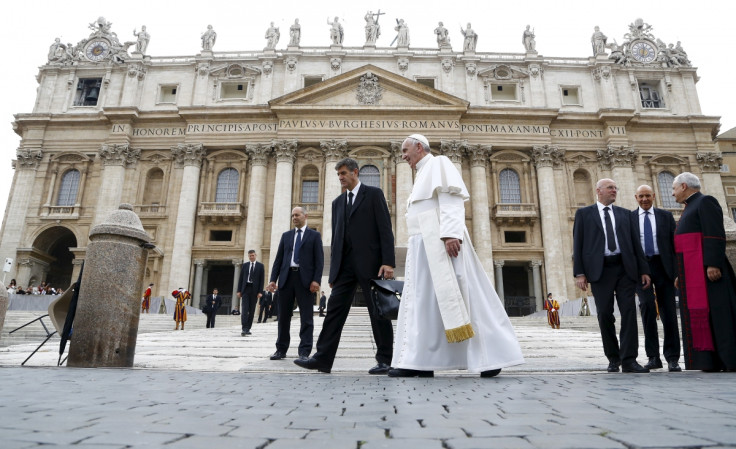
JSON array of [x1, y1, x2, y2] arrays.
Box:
[[271, 227, 325, 289]]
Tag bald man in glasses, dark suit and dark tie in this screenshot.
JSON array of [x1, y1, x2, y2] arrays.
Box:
[[573, 179, 651, 373]]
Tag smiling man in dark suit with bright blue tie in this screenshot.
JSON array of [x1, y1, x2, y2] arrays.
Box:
[[631, 185, 682, 372]]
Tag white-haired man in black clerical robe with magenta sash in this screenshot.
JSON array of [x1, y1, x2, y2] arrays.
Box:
[[672, 172, 736, 371]]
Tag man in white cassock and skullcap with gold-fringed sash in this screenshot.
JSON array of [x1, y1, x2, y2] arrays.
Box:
[[388, 134, 524, 377]]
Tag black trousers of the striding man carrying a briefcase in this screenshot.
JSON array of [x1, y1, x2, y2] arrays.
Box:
[[314, 256, 394, 368]]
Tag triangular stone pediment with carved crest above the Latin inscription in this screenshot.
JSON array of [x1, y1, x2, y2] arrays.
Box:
[[269, 65, 469, 112]]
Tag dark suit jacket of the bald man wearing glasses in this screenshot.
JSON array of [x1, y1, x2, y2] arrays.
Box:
[[572, 204, 649, 283]]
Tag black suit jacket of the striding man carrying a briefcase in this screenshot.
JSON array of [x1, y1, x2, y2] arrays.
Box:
[[329, 184, 396, 284]]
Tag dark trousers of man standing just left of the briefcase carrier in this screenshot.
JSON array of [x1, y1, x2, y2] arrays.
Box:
[[276, 271, 314, 357]]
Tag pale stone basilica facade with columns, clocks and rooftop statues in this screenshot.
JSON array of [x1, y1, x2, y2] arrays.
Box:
[[0, 18, 730, 315]]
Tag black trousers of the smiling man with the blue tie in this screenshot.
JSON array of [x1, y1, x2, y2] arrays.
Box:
[[636, 256, 680, 362]]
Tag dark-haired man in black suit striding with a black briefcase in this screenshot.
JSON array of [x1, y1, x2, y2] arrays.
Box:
[[294, 158, 396, 374]]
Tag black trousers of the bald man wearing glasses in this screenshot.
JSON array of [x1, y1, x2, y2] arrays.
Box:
[[590, 261, 639, 365]]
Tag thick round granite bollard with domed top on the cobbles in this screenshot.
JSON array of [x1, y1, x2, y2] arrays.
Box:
[[67, 204, 152, 368]]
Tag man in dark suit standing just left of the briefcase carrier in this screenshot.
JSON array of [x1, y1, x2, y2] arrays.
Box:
[[268, 207, 325, 361]]
